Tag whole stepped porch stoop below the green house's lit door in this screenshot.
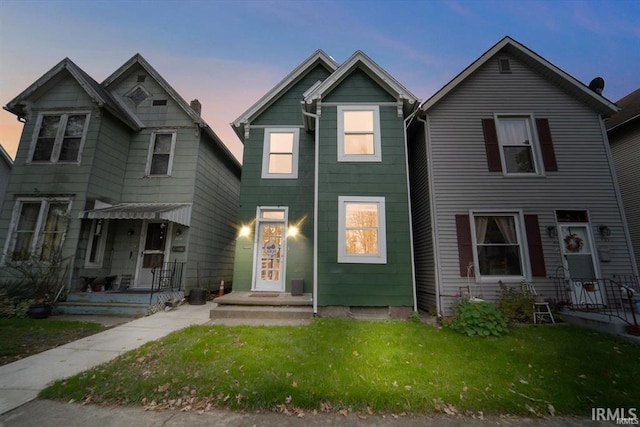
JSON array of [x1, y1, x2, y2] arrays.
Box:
[[210, 292, 313, 325]]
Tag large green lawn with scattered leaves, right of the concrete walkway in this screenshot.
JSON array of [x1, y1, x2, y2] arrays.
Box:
[[41, 319, 640, 416]]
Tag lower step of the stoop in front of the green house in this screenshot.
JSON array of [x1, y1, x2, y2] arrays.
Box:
[[210, 304, 313, 325]]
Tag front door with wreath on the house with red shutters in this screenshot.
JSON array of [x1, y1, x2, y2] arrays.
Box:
[[559, 223, 605, 306]]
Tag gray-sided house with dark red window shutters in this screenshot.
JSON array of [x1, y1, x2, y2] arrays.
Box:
[[409, 37, 637, 315]]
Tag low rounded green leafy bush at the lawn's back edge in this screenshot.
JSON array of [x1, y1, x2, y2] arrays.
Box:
[[449, 299, 508, 337]]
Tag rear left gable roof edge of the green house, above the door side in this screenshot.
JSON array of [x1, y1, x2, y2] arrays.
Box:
[[231, 49, 338, 141]]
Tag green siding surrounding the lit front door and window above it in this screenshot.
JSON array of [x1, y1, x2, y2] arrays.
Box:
[[233, 66, 329, 292]]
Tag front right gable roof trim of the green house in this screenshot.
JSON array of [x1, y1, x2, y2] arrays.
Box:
[[304, 50, 418, 115]]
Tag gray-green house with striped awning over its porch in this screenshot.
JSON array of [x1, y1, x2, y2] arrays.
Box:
[[0, 54, 241, 306]]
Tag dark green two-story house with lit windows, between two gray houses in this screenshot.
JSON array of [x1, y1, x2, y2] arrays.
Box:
[[232, 50, 418, 316]]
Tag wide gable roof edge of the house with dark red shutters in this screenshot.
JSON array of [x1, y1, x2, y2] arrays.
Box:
[[420, 36, 618, 116]]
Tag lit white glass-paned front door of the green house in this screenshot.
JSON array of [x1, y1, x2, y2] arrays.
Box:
[[253, 207, 287, 292]]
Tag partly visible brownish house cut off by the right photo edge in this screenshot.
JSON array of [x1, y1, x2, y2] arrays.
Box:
[[605, 88, 640, 272]]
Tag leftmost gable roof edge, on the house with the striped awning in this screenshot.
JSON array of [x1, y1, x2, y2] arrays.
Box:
[[3, 58, 140, 130]]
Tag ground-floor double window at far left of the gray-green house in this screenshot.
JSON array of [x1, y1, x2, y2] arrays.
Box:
[[5, 199, 71, 261]]
